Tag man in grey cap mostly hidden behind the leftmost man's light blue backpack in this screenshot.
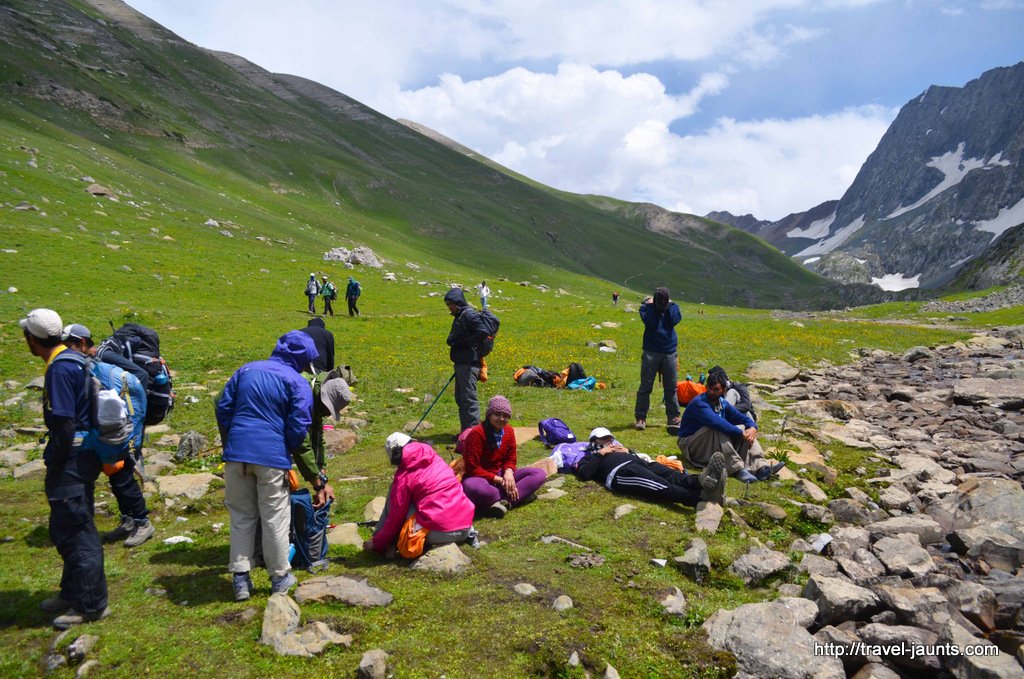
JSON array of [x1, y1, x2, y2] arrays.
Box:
[[60, 323, 157, 547]]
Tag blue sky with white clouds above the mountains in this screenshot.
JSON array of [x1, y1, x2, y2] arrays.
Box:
[[128, 0, 1024, 219]]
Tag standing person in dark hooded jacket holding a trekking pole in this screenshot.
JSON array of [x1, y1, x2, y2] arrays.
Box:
[[444, 288, 486, 431]]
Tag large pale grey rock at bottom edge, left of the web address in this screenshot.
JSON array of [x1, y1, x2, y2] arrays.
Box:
[[703, 602, 846, 679]]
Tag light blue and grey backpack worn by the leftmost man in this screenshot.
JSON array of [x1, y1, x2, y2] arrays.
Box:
[[54, 351, 146, 464]]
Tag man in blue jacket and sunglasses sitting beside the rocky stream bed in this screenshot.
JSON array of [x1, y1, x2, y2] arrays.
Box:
[[677, 371, 784, 483]]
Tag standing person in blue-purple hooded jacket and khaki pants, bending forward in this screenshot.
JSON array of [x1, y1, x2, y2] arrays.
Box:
[[217, 330, 319, 601]]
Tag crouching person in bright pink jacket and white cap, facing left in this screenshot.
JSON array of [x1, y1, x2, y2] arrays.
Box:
[[362, 431, 476, 554]]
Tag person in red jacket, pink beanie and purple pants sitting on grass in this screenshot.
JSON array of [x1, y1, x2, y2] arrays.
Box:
[[462, 396, 547, 518]]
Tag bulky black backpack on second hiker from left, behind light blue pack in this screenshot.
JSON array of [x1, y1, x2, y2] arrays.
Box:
[[96, 323, 174, 425]]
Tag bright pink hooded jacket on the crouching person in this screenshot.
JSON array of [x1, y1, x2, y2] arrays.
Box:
[[373, 441, 474, 553]]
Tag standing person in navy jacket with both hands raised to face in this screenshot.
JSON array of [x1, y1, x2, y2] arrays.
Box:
[[633, 288, 682, 430]]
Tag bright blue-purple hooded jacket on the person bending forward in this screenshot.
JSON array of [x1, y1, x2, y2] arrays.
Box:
[[217, 330, 317, 469]]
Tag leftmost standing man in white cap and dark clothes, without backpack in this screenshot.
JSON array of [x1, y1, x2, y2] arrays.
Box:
[[18, 308, 110, 630]]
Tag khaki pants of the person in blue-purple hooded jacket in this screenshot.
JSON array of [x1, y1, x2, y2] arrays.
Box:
[[224, 462, 292, 579]]
